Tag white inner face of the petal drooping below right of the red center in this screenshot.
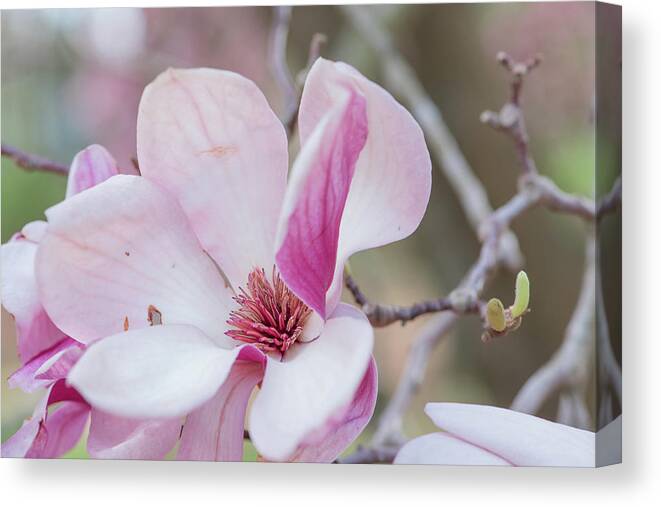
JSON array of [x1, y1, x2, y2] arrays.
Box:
[[249, 304, 374, 461]]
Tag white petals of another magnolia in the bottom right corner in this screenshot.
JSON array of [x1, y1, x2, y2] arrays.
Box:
[[394, 403, 595, 467]]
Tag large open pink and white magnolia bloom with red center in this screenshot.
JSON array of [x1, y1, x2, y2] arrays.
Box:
[[36, 59, 431, 461]]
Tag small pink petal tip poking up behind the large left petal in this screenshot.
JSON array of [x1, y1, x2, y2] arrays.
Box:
[[66, 144, 119, 198]]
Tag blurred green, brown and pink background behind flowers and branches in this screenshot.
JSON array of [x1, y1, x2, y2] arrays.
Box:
[[2, 2, 621, 457]]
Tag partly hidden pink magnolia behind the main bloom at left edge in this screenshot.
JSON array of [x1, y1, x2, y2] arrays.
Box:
[[0, 146, 181, 459]]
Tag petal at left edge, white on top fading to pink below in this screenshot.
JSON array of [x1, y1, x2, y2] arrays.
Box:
[[0, 222, 65, 364]]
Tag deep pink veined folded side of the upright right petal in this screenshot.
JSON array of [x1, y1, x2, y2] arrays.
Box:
[[276, 89, 367, 318]]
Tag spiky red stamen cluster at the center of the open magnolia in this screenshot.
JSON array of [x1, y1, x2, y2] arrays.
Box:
[[225, 266, 312, 358]]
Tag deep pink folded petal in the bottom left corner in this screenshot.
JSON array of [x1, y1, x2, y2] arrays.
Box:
[[0, 380, 89, 458]]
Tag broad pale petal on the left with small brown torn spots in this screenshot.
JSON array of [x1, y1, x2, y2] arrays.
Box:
[[36, 175, 234, 346]]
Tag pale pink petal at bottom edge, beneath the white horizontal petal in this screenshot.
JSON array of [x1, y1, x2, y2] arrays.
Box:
[[87, 409, 181, 460]]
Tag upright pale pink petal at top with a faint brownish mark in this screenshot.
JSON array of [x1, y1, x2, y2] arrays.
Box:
[[138, 69, 288, 288]]
